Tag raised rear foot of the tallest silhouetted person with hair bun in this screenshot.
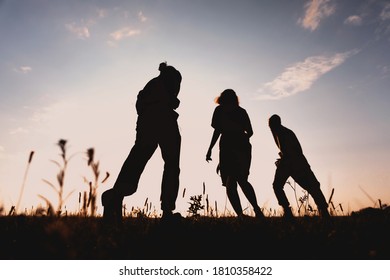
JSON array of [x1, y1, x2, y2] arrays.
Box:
[[102, 189, 123, 227]]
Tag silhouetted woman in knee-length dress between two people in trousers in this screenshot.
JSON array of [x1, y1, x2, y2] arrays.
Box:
[[206, 89, 264, 218]]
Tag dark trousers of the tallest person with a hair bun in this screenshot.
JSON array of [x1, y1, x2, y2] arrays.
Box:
[[113, 117, 181, 211]]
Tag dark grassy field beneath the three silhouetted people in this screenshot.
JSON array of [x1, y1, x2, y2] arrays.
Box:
[[0, 210, 390, 260]]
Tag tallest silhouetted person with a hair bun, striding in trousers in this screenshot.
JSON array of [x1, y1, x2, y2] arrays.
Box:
[[102, 63, 182, 224]]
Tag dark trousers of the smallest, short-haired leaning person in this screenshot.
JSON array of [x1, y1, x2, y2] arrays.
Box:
[[273, 159, 328, 210]]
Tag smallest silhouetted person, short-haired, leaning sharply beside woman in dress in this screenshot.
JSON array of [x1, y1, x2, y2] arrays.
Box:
[[268, 115, 329, 218]]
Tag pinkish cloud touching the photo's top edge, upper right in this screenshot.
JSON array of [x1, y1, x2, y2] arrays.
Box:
[[298, 0, 336, 31]]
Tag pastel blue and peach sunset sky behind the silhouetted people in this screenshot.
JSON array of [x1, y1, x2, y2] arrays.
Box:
[[0, 0, 390, 215]]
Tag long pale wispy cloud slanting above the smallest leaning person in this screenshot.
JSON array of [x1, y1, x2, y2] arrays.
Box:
[[257, 50, 358, 100]]
